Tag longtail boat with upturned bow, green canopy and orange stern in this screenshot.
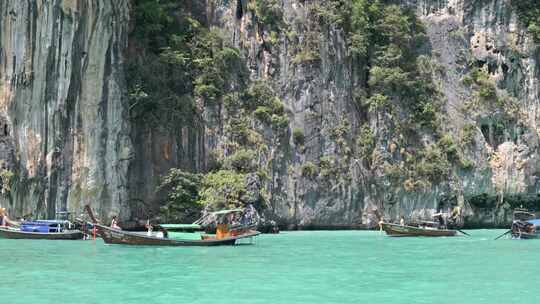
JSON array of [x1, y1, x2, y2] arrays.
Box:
[[85, 206, 260, 246]]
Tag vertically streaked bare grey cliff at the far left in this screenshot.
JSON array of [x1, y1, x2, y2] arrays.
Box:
[[0, 0, 132, 218]]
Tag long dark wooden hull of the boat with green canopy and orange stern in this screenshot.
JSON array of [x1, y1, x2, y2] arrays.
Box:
[[95, 224, 260, 246]]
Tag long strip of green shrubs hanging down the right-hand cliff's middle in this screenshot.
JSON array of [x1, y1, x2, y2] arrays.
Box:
[[340, 0, 456, 190]]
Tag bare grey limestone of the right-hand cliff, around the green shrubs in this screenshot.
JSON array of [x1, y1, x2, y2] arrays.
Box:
[[205, 0, 540, 225]]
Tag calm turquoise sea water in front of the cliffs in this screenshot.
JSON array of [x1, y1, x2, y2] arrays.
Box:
[[0, 230, 540, 304]]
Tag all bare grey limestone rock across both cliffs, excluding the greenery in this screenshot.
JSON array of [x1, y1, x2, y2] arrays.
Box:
[[0, 0, 540, 227]]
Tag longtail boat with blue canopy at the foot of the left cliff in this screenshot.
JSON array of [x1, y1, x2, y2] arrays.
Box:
[[0, 221, 83, 240]]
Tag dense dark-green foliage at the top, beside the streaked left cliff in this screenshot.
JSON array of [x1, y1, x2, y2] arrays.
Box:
[[127, 0, 247, 127]]
